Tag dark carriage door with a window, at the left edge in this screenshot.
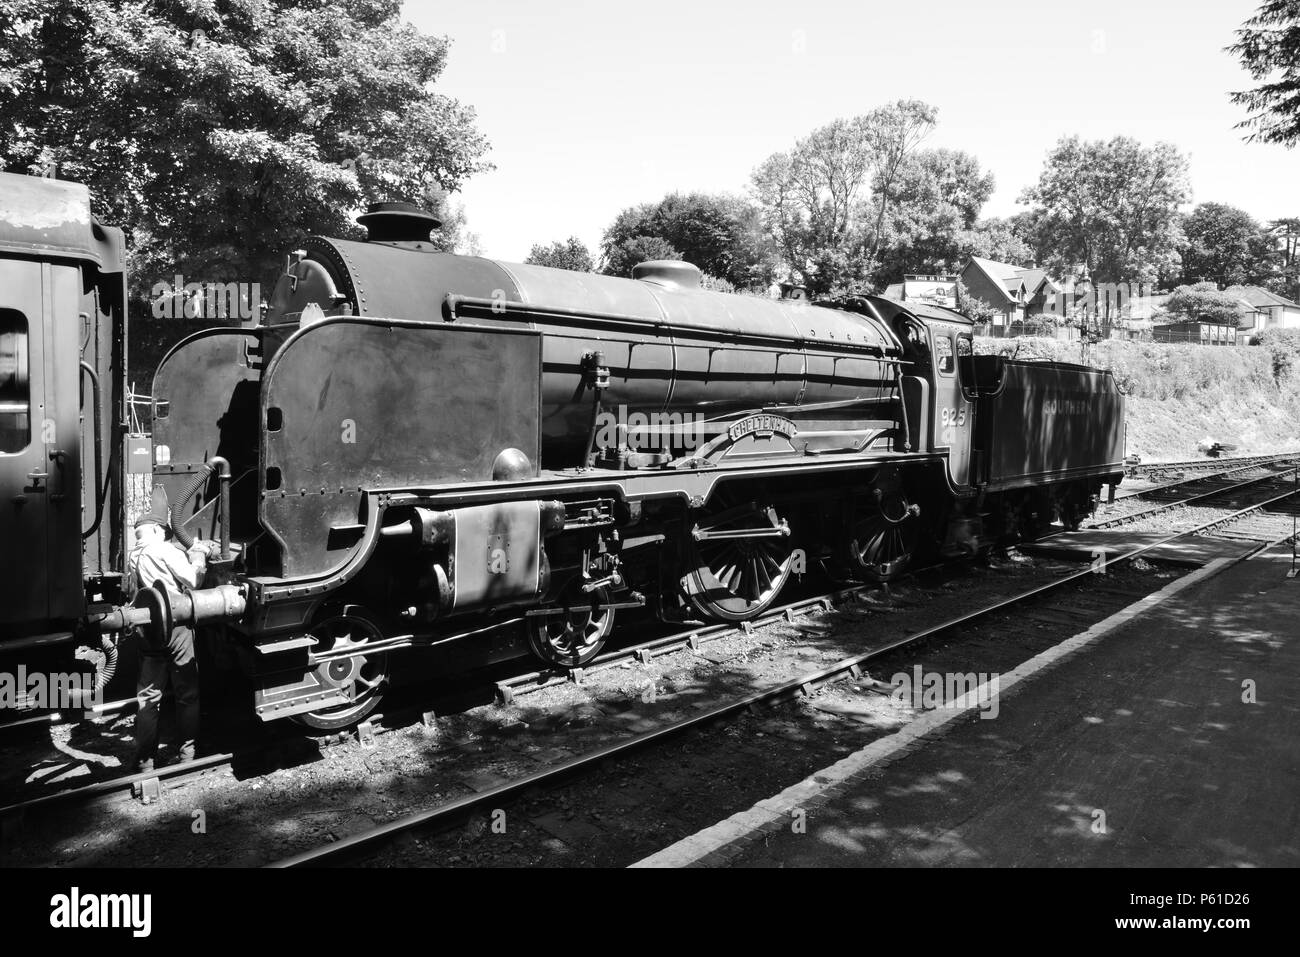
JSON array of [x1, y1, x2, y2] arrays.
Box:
[[0, 259, 82, 632]]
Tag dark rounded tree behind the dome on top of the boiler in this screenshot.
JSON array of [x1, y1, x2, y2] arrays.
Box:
[[601, 192, 775, 286]]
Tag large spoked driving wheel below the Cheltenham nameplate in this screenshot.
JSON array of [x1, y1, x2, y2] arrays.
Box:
[[683, 498, 794, 622]]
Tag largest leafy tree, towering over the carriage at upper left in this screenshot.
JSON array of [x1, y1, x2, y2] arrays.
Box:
[[0, 0, 488, 287]]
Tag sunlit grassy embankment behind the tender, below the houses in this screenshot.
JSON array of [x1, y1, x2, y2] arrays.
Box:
[[975, 332, 1300, 462]]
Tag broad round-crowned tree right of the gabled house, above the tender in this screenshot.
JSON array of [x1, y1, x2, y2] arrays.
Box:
[[1021, 137, 1188, 283]]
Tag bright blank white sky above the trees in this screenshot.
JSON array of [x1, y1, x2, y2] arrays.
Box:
[[404, 0, 1300, 261]]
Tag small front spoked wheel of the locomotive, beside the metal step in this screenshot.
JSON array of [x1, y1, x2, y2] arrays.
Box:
[[294, 612, 389, 731]]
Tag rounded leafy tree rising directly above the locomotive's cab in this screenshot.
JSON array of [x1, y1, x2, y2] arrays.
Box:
[[872, 150, 993, 278]]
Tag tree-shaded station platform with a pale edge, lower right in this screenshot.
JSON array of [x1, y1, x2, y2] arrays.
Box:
[[642, 547, 1300, 867]]
